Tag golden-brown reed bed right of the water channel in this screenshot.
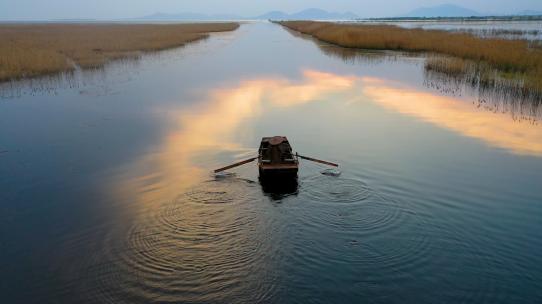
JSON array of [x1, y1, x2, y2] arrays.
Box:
[[279, 21, 542, 100]]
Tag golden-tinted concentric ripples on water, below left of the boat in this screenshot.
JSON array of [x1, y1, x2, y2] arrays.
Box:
[[82, 178, 276, 303]]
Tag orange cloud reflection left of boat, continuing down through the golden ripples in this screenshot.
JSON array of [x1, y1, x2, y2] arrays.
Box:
[[107, 71, 366, 302]]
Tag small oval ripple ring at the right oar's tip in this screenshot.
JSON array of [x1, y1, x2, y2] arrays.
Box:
[[300, 175, 371, 203]]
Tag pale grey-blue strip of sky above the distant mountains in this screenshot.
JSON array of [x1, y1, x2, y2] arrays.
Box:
[[0, 0, 542, 20]]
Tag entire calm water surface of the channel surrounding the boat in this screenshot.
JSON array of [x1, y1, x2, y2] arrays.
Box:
[[0, 23, 542, 303]]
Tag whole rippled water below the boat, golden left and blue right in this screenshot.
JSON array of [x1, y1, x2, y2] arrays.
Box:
[[58, 175, 510, 303]]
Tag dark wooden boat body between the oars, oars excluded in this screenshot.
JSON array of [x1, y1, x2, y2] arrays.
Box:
[[258, 136, 299, 179]]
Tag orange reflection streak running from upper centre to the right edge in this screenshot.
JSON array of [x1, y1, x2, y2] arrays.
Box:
[[362, 78, 542, 155]]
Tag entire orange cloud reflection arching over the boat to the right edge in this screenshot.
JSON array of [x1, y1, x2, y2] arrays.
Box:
[[120, 70, 542, 205]]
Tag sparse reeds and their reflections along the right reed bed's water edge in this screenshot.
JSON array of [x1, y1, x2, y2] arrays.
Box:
[[284, 25, 542, 124]]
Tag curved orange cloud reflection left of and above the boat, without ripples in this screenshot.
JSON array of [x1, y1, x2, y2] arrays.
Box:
[[117, 70, 356, 201]]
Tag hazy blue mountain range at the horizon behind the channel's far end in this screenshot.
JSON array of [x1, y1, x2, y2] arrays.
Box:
[[135, 8, 358, 21]]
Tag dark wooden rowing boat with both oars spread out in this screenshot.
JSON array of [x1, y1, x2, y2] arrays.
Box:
[[214, 136, 339, 183]]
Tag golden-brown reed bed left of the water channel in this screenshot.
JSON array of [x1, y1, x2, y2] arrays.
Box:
[[0, 23, 239, 81]]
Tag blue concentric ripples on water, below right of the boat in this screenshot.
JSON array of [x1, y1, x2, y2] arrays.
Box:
[[292, 175, 436, 294]]
